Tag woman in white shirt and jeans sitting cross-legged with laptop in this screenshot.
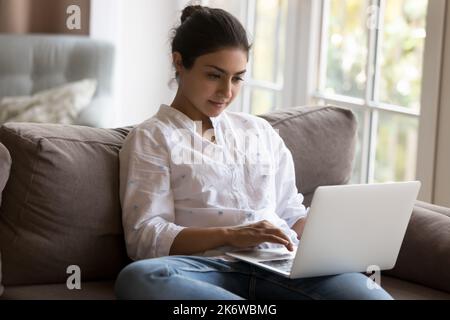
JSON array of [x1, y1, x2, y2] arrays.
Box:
[[115, 6, 391, 300]]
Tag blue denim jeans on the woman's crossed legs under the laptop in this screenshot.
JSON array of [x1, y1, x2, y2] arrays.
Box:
[[115, 256, 392, 300]]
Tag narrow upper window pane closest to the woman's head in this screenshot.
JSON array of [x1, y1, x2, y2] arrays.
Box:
[[252, 0, 288, 83]]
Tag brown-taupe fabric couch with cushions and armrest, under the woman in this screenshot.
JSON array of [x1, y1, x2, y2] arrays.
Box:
[[0, 107, 450, 299]]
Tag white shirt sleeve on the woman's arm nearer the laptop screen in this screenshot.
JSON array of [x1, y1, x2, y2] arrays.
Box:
[[273, 128, 307, 228]]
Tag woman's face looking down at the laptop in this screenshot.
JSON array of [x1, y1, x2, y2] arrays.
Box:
[[174, 48, 247, 120]]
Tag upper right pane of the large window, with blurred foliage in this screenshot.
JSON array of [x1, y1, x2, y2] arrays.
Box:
[[380, 0, 428, 110]]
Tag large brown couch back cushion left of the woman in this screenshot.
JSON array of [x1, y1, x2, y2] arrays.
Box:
[[0, 123, 132, 285]]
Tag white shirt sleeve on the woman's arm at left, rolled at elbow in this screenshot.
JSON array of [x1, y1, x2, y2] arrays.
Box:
[[119, 127, 183, 260]]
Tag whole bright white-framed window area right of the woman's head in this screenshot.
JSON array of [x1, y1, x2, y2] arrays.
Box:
[[202, 0, 446, 201]]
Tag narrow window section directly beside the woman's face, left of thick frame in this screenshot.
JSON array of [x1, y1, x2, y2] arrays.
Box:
[[202, 0, 289, 115]]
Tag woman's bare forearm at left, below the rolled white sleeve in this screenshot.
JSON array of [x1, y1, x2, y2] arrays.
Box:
[[169, 228, 228, 255]]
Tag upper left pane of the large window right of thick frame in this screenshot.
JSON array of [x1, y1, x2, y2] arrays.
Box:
[[324, 0, 368, 98]]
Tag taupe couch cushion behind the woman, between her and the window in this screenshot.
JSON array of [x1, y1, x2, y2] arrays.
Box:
[[261, 106, 357, 206]]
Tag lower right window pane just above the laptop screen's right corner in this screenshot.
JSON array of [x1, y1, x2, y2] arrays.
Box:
[[374, 112, 419, 182]]
